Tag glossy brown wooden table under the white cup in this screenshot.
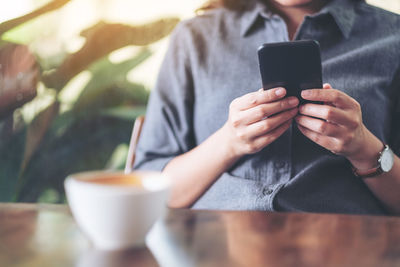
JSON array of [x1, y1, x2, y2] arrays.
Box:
[[0, 204, 400, 267]]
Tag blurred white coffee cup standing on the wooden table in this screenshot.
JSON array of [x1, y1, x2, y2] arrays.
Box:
[[64, 171, 170, 250]]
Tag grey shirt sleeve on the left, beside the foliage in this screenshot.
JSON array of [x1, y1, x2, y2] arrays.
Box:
[[134, 23, 195, 171]]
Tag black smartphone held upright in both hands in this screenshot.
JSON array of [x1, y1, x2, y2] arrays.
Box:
[[258, 40, 322, 104]]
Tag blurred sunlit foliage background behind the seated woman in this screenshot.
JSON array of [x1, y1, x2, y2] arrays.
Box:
[[0, 0, 400, 203]]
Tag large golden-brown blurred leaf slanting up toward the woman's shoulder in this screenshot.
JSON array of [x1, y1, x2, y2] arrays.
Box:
[[43, 18, 179, 90]]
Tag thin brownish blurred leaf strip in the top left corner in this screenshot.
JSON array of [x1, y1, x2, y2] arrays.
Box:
[[0, 0, 71, 36]]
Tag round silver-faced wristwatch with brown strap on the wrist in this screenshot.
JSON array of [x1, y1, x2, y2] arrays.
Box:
[[352, 144, 394, 178]]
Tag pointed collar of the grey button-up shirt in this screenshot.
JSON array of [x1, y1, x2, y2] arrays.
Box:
[[240, 0, 360, 38]]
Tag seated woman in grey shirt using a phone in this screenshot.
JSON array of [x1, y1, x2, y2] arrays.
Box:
[[136, 0, 400, 214]]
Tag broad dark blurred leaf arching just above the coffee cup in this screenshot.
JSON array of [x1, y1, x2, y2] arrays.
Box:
[[17, 116, 133, 202]]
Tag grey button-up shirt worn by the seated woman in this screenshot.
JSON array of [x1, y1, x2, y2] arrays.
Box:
[[135, 0, 400, 214]]
